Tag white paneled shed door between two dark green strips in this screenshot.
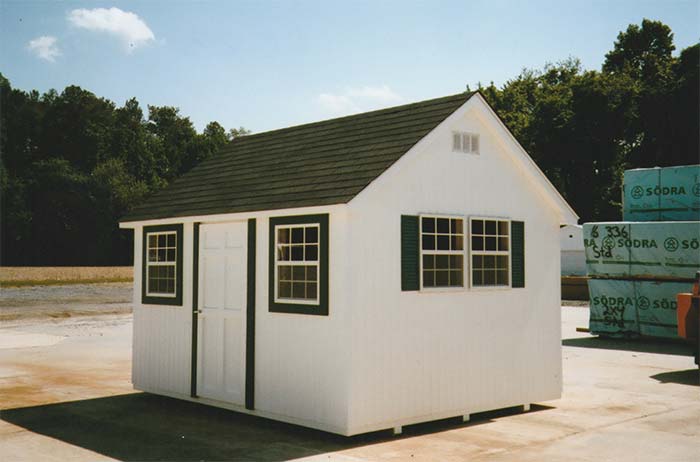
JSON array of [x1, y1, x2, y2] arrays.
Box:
[[197, 222, 247, 405]]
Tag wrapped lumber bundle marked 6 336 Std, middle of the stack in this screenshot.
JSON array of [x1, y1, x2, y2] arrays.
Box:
[[583, 221, 700, 279]]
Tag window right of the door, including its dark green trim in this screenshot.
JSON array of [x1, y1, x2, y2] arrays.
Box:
[[270, 214, 328, 315]]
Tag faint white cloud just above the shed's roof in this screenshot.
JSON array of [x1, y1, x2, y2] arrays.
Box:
[[316, 85, 404, 115]]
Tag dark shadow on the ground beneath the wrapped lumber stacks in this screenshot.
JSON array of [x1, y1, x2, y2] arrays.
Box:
[[561, 337, 693, 356]]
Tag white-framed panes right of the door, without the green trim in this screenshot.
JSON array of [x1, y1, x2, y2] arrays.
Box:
[[276, 224, 319, 302]]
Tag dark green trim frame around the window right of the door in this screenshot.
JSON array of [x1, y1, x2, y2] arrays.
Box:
[[268, 214, 329, 316]]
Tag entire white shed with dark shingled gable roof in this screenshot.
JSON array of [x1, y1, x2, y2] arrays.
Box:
[[121, 93, 578, 435]]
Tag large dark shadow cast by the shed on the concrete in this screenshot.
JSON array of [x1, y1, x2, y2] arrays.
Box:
[[0, 393, 551, 461]]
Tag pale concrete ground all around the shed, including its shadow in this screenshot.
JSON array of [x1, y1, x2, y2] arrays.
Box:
[[0, 285, 700, 462]]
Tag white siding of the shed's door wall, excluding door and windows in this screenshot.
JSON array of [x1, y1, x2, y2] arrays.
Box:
[[132, 205, 351, 433]]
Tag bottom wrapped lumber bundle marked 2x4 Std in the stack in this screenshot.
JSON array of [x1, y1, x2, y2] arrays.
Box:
[[588, 279, 693, 338]]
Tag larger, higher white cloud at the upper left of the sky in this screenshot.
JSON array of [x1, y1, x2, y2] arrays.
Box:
[[68, 7, 156, 51]]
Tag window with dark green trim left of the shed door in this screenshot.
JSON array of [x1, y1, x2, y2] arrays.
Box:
[[142, 225, 182, 305]]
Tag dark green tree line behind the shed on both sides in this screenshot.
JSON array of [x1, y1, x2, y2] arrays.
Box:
[[0, 20, 700, 265]]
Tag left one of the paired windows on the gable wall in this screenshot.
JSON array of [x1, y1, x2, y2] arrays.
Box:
[[420, 216, 464, 288]]
